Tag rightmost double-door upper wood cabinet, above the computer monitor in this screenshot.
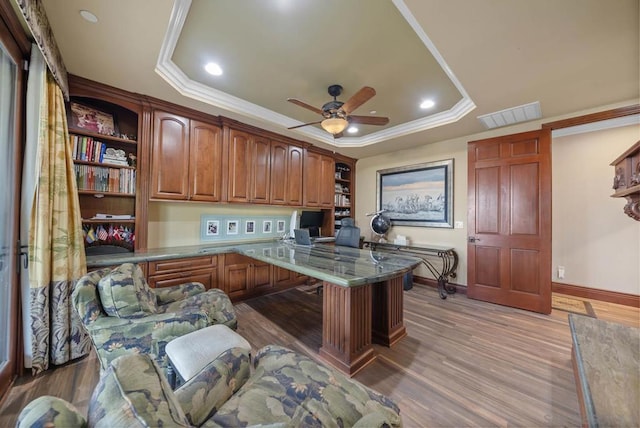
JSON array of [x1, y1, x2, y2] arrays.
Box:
[[304, 150, 335, 208]]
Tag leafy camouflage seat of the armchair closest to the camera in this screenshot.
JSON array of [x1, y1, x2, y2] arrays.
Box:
[[211, 345, 402, 427]]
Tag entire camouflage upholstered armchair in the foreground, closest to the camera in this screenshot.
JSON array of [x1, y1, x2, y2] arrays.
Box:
[[17, 345, 402, 428]]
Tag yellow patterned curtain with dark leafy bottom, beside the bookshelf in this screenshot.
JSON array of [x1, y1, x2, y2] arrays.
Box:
[[29, 73, 90, 374]]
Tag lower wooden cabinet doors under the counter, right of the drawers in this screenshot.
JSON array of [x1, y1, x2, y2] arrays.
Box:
[[221, 254, 273, 300]]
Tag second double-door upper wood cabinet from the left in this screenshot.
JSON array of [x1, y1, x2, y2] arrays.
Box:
[[227, 129, 271, 204]]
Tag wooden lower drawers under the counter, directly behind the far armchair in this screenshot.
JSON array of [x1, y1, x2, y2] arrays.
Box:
[[147, 255, 219, 290]]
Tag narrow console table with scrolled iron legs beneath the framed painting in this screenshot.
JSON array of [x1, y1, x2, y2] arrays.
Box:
[[364, 241, 458, 299]]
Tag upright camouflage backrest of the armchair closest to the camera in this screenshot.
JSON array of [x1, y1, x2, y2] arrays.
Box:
[[88, 354, 190, 427]]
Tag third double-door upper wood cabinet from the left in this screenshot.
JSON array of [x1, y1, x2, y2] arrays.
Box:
[[271, 141, 303, 206]]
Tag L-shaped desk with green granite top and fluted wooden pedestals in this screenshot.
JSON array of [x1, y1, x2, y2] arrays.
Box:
[[87, 240, 422, 376]]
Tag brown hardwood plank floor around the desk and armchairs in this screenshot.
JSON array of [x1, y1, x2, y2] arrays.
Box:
[[0, 285, 640, 427]]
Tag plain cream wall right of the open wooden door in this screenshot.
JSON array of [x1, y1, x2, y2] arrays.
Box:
[[552, 126, 640, 294]]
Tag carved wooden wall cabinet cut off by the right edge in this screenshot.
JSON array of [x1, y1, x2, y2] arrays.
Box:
[[611, 141, 640, 221]]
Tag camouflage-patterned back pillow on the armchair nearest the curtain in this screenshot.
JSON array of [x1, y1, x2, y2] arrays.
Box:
[[98, 263, 158, 318]]
